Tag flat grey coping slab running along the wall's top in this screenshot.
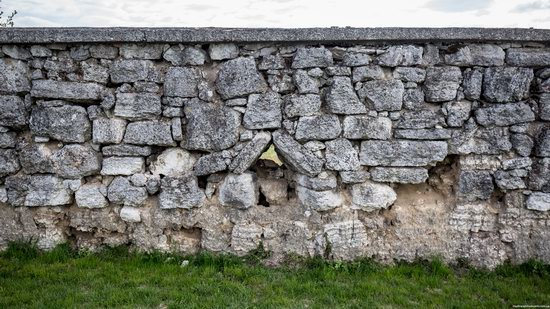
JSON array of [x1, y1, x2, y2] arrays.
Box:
[[0, 27, 550, 44]]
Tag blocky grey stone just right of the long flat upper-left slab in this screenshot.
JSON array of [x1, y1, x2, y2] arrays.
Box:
[[114, 93, 162, 120]]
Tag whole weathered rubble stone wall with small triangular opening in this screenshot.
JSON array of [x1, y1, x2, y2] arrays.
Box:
[[0, 29, 550, 267]]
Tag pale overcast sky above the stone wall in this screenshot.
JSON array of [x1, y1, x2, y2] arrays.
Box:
[[2, 0, 550, 29]]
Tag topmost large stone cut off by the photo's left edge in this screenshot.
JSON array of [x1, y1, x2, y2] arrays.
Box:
[[0, 58, 31, 93]]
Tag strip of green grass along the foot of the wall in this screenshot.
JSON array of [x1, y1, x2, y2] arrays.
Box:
[[0, 243, 550, 308]]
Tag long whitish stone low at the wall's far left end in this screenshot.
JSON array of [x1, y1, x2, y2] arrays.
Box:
[[6, 175, 73, 207]]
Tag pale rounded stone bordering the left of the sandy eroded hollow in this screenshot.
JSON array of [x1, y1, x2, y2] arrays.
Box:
[[351, 181, 397, 212]]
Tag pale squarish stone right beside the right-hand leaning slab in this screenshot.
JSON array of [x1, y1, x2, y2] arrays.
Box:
[[325, 138, 360, 171]]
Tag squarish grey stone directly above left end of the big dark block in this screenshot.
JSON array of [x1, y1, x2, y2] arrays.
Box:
[[164, 67, 201, 98]]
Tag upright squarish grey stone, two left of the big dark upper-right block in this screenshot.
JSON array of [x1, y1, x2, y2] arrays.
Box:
[[424, 67, 462, 102]]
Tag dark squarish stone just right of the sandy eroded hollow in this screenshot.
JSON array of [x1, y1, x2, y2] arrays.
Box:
[[456, 171, 495, 202]]
